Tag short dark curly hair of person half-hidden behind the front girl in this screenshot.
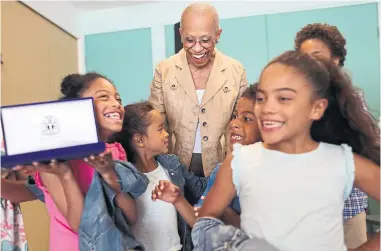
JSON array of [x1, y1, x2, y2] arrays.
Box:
[[294, 23, 347, 66]]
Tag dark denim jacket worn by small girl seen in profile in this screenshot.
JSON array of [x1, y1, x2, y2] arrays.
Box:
[[156, 154, 208, 251]]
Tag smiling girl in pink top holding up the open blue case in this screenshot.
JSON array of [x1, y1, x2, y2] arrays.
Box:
[[17, 73, 136, 251]]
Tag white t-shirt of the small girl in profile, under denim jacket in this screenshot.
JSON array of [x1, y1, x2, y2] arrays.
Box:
[[131, 163, 182, 251]]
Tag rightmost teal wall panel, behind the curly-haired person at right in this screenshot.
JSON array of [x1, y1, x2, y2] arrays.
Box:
[[267, 3, 380, 119]]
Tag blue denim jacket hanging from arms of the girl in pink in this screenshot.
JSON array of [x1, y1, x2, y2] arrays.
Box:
[[78, 161, 149, 251]]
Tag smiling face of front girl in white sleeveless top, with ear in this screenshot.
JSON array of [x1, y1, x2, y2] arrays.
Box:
[[254, 63, 327, 148]]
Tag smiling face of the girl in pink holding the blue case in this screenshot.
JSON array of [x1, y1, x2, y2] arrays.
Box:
[[82, 78, 124, 141]]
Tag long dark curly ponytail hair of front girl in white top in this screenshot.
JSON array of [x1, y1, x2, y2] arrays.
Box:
[[265, 51, 380, 165]]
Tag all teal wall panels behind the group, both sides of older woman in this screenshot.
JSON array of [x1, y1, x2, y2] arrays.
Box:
[[85, 3, 380, 213]]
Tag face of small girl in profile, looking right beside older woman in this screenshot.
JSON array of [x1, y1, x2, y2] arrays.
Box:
[[143, 110, 169, 156]]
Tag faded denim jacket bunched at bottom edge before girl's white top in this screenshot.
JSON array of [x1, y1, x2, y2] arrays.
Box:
[[192, 217, 280, 251]]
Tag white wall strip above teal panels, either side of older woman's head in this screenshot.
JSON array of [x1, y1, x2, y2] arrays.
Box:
[[81, 0, 377, 35]]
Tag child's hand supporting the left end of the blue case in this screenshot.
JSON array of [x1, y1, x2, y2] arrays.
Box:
[[14, 159, 71, 177]]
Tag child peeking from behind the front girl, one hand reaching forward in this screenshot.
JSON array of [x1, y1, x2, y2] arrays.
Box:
[[152, 84, 260, 227]]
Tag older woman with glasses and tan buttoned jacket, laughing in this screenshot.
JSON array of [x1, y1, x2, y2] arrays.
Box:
[[149, 3, 247, 176]]
